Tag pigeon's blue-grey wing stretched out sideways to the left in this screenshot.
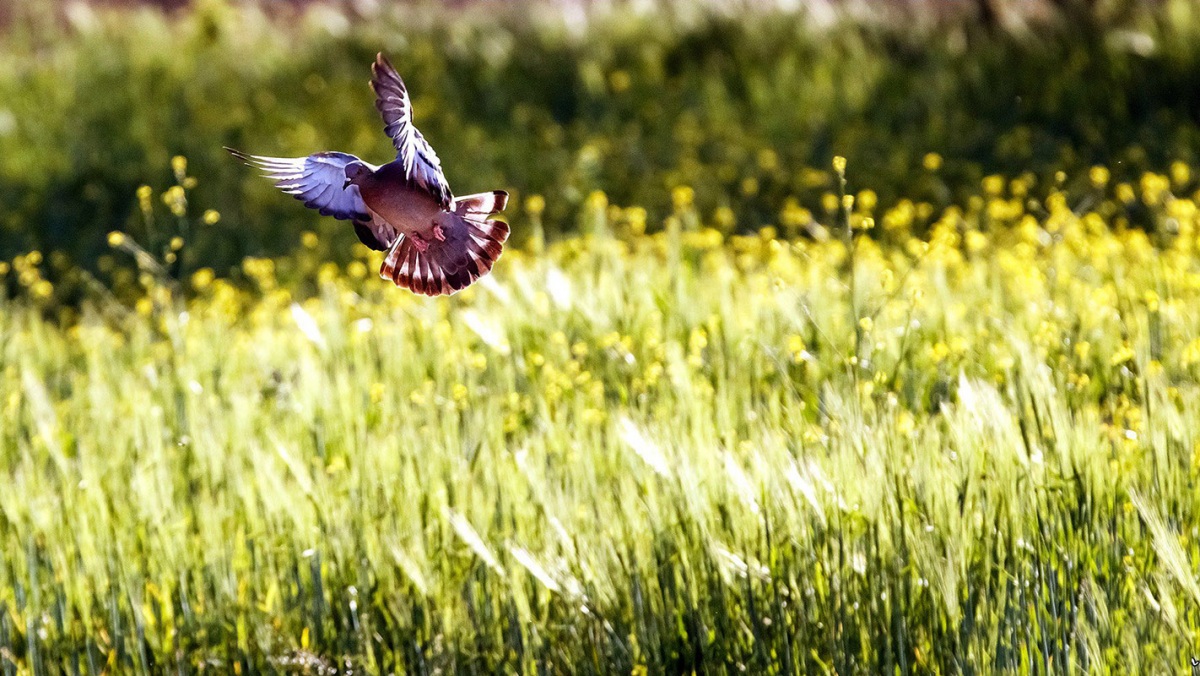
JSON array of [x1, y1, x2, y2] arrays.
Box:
[[226, 148, 378, 222]]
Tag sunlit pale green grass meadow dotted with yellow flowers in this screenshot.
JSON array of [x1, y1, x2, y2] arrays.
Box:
[[0, 4, 1200, 675]]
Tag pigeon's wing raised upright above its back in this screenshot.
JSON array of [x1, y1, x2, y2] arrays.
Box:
[[371, 54, 454, 209]]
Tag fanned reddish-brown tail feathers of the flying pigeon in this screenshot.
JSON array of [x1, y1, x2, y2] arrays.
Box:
[[379, 211, 509, 295]]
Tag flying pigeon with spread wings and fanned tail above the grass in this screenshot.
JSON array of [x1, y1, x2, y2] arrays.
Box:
[[226, 54, 509, 295]]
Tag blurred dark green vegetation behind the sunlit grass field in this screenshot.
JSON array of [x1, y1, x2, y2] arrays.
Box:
[[7, 0, 1200, 293]]
